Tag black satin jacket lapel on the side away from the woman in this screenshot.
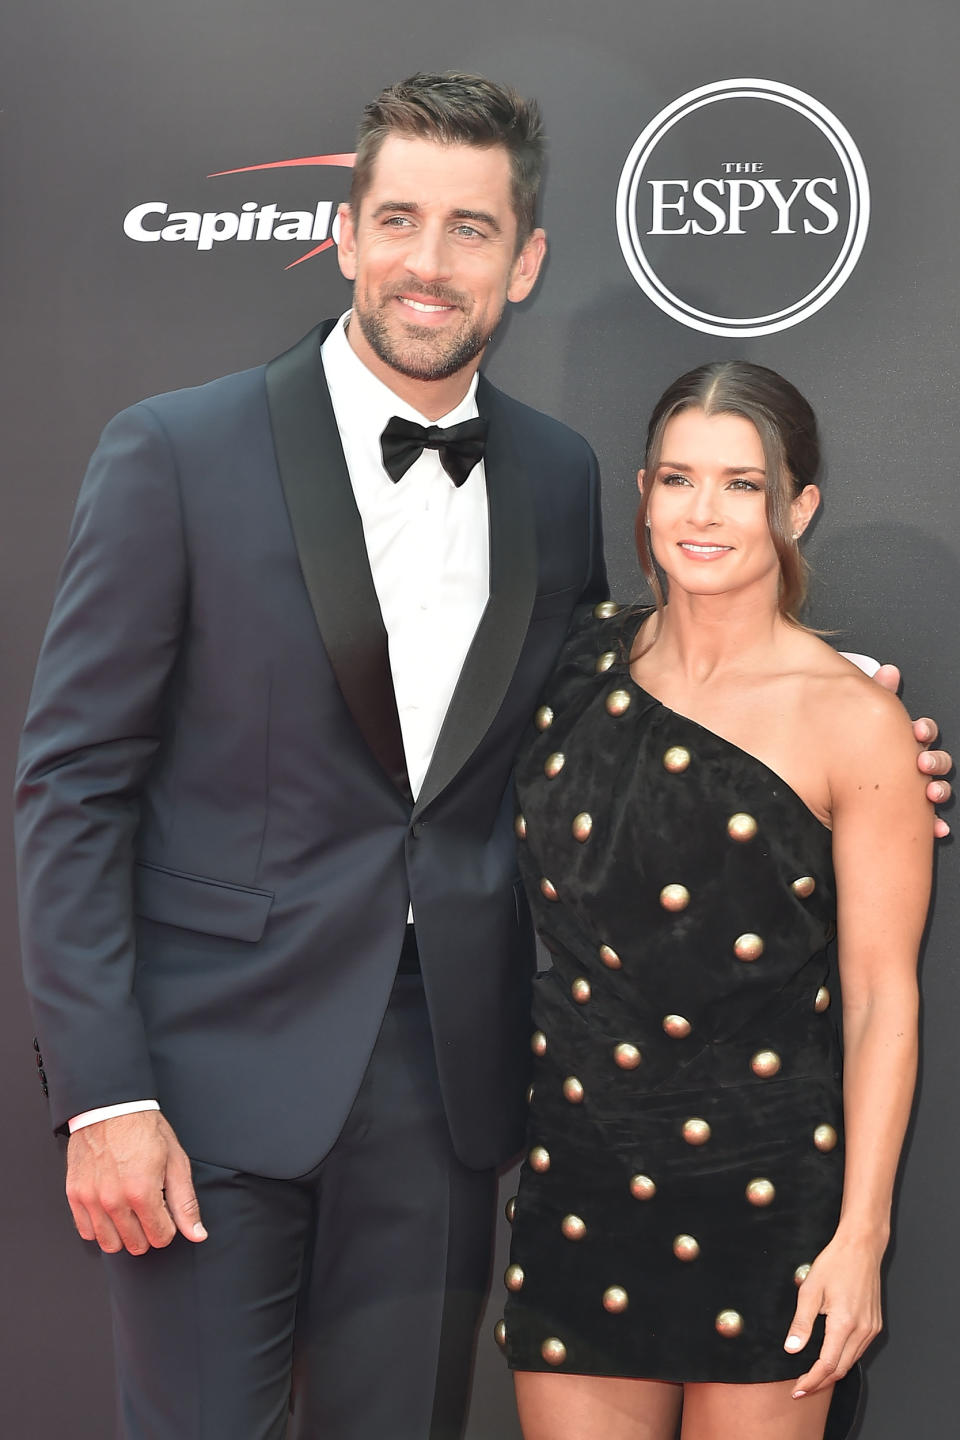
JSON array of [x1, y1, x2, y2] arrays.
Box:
[[266, 324, 412, 799]]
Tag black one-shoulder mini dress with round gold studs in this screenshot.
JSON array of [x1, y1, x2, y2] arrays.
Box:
[[501, 605, 851, 1436]]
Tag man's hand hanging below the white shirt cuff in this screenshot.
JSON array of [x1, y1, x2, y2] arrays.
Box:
[[66, 1110, 207, 1256]]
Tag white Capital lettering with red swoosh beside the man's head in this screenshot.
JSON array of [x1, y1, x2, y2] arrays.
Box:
[[124, 154, 357, 269]]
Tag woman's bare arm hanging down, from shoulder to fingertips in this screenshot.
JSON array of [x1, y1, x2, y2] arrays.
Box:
[[786, 681, 933, 1395]]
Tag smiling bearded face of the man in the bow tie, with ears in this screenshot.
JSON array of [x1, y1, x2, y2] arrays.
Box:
[[340, 135, 544, 394]]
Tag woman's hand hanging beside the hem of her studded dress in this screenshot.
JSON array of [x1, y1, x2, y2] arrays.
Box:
[[783, 1236, 884, 1400]]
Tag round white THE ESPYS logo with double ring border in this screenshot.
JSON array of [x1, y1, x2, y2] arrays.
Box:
[[616, 79, 869, 336]]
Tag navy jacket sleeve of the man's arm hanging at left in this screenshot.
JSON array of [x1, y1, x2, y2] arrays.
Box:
[[14, 405, 187, 1129]]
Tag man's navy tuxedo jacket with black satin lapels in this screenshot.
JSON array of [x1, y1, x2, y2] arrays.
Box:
[[17, 323, 606, 1176]]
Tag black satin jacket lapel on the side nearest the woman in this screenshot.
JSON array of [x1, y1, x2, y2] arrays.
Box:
[[415, 379, 537, 814]]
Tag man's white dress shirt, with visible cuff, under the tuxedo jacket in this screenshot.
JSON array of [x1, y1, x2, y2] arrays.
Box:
[[69, 311, 489, 1133]]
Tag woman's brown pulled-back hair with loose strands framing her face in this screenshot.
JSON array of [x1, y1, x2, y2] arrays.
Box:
[[636, 360, 820, 624]]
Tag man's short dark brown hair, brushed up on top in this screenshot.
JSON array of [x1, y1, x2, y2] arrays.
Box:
[[350, 71, 544, 249]]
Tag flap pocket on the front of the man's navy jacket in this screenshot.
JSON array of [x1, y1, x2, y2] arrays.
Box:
[[134, 861, 273, 943]]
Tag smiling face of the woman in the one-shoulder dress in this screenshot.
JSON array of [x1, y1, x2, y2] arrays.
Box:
[[640, 409, 816, 603]]
